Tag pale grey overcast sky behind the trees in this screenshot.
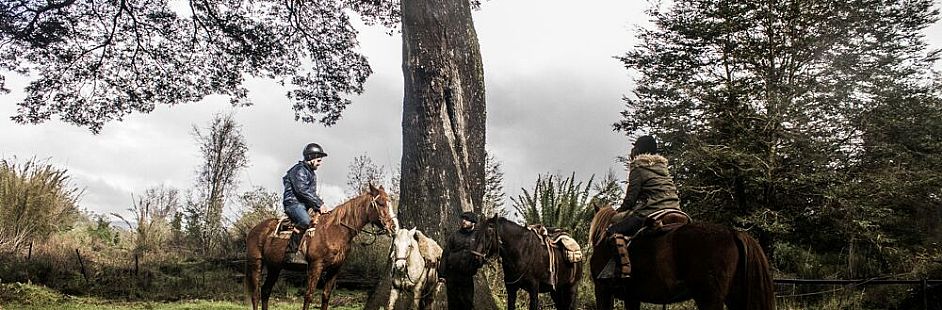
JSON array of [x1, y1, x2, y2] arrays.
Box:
[[0, 0, 942, 223]]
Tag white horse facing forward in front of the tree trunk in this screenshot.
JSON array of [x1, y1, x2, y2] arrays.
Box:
[[388, 228, 442, 310]]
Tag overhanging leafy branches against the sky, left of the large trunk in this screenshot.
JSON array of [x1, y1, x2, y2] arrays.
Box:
[[0, 0, 399, 132]]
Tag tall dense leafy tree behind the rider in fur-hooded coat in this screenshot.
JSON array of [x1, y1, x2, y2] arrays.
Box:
[[615, 0, 938, 268]]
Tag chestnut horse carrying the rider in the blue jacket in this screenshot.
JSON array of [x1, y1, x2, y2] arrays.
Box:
[[245, 185, 396, 310]]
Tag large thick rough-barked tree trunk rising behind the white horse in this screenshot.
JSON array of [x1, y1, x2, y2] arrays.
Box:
[[399, 0, 486, 240]]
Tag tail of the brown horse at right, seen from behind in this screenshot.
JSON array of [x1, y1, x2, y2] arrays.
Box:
[[735, 232, 775, 310]]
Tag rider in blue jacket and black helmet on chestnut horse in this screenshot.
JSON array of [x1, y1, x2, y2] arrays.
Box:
[[282, 143, 327, 264]]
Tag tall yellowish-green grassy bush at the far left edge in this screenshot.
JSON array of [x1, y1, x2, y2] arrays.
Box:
[[0, 159, 81, 252]]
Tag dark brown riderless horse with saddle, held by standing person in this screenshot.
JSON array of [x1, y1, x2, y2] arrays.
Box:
[[471, 216, 582, 310]]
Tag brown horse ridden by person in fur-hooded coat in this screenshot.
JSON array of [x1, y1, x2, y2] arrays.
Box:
[[589, 205, 775, 310]]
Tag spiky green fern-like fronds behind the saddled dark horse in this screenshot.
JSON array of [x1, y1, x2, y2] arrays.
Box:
[[511, 172, 620, 244]]
